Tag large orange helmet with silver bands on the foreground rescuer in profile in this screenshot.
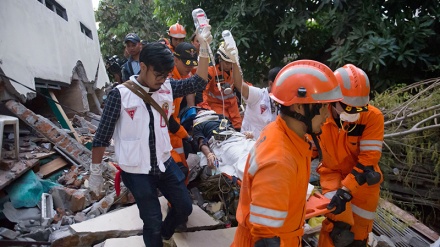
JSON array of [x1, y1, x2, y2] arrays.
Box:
[[270, 60, 342, 106]]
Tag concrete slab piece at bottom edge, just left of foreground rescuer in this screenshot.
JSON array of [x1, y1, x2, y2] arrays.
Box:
[[173, 227, 237, 247]]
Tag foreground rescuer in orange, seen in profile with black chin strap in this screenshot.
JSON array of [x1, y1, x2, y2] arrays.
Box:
[[231, 60, 342, 247]]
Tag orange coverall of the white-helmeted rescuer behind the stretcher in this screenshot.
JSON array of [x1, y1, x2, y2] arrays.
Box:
[[199, 64, 242, 129]]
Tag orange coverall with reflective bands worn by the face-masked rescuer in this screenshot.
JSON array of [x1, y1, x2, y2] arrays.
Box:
[[317, 105, 384, 247]]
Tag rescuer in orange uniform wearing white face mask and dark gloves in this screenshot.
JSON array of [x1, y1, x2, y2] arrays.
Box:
[[317, 64, 384, 247]]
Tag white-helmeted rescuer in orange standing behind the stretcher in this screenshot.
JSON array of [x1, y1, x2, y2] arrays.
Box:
[[198, 43, 242, 131]]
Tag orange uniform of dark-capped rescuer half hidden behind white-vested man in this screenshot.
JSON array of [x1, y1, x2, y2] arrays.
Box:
[[169, 66, 191, 184]]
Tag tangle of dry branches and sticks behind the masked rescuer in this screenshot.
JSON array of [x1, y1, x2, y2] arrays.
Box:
[[372, 78, 440, 232]]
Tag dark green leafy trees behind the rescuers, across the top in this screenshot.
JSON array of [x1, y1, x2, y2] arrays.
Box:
[[96, 0, 440, 92]]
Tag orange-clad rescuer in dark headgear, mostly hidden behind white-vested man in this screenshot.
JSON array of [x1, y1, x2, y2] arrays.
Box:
[[169, 42, 198, 184]]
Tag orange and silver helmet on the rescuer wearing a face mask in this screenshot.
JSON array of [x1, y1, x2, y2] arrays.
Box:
[[335, 64, 370, 107]]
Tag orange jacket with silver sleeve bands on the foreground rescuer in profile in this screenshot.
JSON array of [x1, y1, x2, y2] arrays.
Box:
[[231, 116, 312, 247]]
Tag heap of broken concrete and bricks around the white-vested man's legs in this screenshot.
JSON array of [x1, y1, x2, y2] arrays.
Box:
[[0, 93, 241, 246]]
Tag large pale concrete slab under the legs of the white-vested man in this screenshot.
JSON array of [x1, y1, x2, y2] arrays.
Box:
[[50, 197, 221, 246]]
